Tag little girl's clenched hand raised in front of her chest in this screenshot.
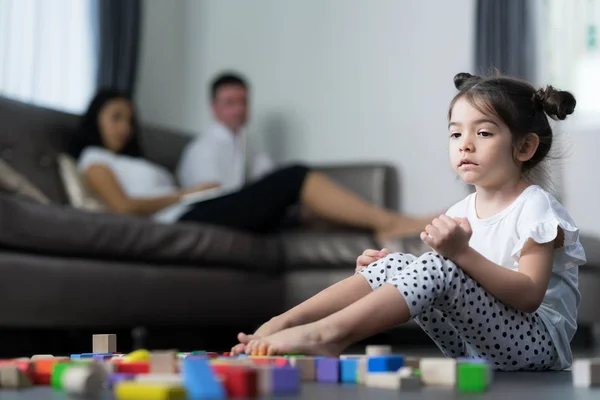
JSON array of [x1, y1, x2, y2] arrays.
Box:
[[421, 214, 473, 259]]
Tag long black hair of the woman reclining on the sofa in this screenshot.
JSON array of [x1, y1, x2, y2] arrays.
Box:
[[69, 89, 142, 159]]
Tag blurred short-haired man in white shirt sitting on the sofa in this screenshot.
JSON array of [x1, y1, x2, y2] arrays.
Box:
[[177, 73, 275, 190]]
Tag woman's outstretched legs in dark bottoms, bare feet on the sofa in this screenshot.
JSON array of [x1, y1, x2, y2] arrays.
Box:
[[180, 166, 431, 239]]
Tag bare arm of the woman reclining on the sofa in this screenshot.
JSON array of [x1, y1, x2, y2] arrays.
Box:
[[84, 164, 183, 216]]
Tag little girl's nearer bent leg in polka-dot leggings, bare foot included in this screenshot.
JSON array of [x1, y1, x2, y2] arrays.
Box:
[[248, 253, 556, 370]]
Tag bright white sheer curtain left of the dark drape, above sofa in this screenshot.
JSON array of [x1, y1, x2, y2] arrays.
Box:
[[0, 0, 96, 113]]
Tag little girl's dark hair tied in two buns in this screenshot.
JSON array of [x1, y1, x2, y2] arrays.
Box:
[[448, 72, 576, 172]]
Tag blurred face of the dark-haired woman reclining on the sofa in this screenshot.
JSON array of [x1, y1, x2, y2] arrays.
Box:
[[98, 98, 133, 153]]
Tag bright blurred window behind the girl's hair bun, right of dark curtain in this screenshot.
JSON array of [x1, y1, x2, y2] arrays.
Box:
[[539, 0, 600, 119]]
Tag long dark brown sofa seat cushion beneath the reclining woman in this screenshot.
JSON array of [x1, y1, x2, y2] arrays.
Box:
[[0, 195, 280, 272]]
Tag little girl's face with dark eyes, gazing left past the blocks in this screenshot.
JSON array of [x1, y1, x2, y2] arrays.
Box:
[[448, 98, 521, 188]]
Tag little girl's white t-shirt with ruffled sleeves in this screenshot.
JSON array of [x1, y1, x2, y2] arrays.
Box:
[[446, 185, 586, 369]]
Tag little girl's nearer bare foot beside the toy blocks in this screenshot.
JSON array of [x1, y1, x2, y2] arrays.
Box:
[[246, 322, 347, 357]]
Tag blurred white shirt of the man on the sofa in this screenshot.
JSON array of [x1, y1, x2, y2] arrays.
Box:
[[177, 122, 274, 191]]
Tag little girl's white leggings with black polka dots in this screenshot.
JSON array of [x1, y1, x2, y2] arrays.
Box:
[[357, 252, 557, 371]]
